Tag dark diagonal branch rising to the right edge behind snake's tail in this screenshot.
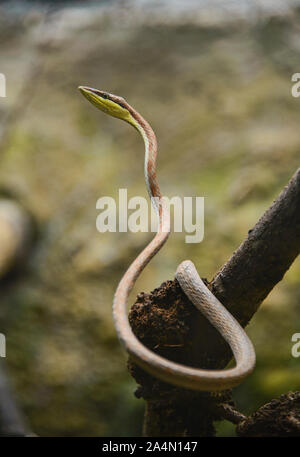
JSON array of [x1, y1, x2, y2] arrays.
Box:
[[191, 168, 300, 368]]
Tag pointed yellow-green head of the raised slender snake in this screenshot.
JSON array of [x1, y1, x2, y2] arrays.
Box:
[[78, 86, 136, 127]]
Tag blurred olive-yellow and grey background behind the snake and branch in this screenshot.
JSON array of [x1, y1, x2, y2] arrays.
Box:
[[0, 0, 300, 436]]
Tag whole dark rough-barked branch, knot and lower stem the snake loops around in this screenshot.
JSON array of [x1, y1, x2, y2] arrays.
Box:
[[129, 169, 300, 436]]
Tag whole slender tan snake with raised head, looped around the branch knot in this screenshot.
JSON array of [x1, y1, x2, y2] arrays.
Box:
[[79, 86, 255, 391]]
